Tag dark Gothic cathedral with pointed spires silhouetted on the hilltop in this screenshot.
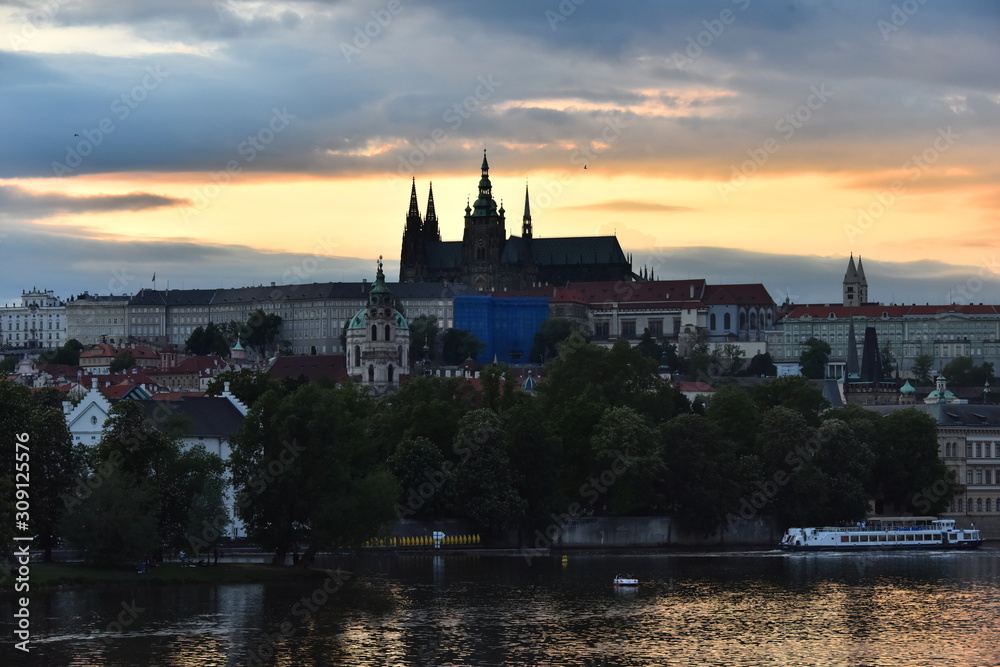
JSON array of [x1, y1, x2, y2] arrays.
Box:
[[399, 151, 635, 292]]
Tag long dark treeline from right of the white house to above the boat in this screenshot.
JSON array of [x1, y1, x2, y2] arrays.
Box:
[[227, 334, 950, 558]]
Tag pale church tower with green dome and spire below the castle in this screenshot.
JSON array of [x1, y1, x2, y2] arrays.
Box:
[[346, 256, 410, 396]]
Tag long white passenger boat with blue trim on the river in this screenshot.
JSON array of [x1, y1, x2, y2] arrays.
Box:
[[778, 516, 983, 551]]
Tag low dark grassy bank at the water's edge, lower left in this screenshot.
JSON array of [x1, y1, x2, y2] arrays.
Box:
[[20, 563, 327, 589]]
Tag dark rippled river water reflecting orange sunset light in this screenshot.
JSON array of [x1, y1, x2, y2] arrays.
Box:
[[7, 548, 1000, 667]]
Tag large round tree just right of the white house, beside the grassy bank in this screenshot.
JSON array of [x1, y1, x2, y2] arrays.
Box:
[[230, 383, 401, 564]]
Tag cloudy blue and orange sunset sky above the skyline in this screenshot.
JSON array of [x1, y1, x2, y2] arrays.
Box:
[[0, 0, 1000, 304]]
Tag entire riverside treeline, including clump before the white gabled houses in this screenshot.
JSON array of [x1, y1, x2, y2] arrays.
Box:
[[0, 333, 952, 562]]
